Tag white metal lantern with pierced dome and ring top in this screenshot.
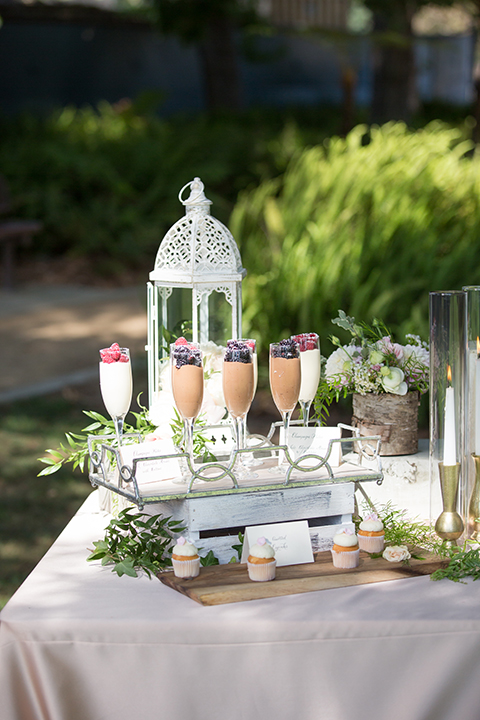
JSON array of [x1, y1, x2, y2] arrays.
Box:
[[146, 178, 246, 405]]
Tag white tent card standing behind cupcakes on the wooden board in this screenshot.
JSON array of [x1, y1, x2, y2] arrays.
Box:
[[240, 520, 313, 567]]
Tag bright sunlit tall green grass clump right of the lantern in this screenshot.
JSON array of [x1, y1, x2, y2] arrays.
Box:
[[230, 122, 480, 348]]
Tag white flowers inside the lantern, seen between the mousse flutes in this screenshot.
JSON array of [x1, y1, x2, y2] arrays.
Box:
[[146, 342, 227, 440]]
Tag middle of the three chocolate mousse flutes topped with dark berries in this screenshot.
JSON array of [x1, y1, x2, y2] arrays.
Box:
[[222, 340, 255, 476]]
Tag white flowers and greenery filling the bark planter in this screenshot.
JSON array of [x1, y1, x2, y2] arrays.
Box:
[[325, 310, 430, 395]]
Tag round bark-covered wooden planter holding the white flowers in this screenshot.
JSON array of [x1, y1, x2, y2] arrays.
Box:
[[352, 391, 420, 455]]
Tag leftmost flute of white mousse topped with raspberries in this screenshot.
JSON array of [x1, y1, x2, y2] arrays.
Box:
[[100, 343, 133, 447]]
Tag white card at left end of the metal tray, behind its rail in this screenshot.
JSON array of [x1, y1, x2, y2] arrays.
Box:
[[122, 439, 182, 486]]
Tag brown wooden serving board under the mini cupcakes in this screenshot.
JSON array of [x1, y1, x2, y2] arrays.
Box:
[[158, 548, 448, 605]]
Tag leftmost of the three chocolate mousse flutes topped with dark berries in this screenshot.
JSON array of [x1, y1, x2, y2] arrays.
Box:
[[170, 337, 203, 476]]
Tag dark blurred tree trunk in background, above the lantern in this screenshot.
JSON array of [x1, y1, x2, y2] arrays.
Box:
[[199, 15, 242, 111]]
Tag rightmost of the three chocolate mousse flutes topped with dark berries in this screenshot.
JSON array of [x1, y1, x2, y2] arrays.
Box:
[[270, 338, 302, 468]]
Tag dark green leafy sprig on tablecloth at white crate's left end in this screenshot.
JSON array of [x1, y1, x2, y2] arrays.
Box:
[[87, 508, 185, 577]]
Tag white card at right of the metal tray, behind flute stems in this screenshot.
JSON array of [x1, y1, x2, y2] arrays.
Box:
[[280, 425, 342, 467]]
